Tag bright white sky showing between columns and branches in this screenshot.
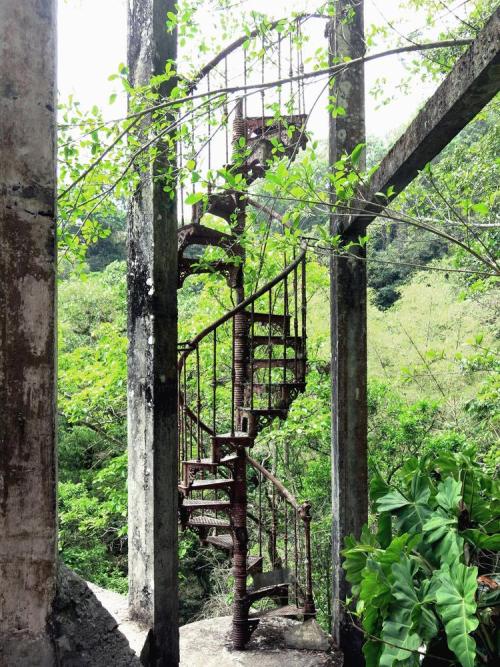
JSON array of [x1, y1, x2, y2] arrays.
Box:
[[58, 0, 460, 138]]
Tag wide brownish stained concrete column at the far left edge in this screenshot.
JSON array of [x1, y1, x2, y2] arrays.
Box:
[[0, 0, 57, 667]]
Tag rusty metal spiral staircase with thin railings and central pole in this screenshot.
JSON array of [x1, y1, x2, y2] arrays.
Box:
[[178, 108, 315, 649]]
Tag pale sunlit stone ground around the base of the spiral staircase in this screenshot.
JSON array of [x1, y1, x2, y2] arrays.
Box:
[[89, 584, 343, 667]]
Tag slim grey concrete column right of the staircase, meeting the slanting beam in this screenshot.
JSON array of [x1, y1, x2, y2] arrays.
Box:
[[330, 0, 368, 667]]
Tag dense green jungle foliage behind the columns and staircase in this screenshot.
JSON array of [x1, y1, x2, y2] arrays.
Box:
[[59, 2, 500, 667]]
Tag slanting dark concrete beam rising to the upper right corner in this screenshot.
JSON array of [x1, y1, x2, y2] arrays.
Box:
[[344, 8, 500, 238]]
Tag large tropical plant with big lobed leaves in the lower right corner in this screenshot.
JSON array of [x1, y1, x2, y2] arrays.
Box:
[[343, 451, 500, 667]]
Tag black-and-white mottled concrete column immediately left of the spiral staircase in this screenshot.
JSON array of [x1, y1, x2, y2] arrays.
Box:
[[128, 0, 179, 667]]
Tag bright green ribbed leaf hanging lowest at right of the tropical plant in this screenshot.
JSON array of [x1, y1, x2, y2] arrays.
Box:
[[435, 563, 479, 667]]
